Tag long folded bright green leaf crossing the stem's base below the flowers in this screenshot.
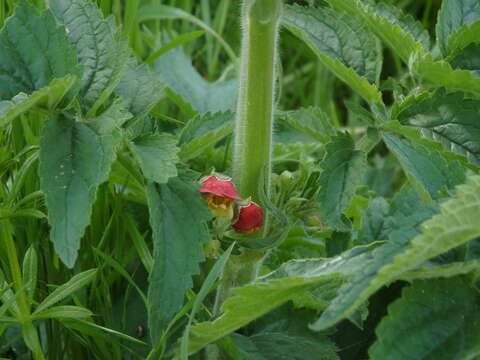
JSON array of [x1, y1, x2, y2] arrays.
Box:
[[189, 243, 380, 353]]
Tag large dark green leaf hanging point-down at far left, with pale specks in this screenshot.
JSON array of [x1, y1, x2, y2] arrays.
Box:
[[40, 110, 121, 267]]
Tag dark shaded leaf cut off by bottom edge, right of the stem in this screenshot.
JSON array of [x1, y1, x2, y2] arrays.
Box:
[[232, 332, 340, 360]]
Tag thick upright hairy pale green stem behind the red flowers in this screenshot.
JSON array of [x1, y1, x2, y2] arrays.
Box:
[[207, 0, 282, 360]]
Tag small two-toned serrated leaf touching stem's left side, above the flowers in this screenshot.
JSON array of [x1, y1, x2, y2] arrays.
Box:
[[179, 111, 235, 161]]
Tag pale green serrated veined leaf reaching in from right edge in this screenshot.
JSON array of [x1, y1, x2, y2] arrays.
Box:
[[375, 175, 480, 292]]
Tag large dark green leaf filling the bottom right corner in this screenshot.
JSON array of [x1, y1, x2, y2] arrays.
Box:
[[369, 277, 480, 360]]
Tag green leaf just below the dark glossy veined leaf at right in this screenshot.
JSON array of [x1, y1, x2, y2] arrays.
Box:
[[383, 134, 465, 199]]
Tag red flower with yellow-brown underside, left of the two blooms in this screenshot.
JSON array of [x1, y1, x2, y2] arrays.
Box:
[[198, 174, 242, 218]]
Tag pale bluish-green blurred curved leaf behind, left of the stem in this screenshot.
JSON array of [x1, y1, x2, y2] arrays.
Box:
[[153, 47, 237, 114]]
